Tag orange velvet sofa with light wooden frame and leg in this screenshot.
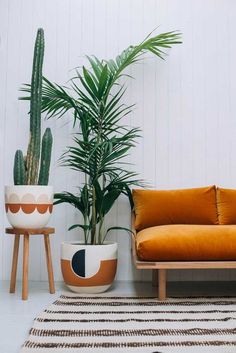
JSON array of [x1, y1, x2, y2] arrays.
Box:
[[132, 185, 236, 300]]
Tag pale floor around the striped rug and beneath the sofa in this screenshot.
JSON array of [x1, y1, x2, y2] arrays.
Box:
[[0, 281, 236, 353]]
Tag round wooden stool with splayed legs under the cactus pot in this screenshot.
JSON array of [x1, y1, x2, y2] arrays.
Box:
[[6, 227, 55, 300]]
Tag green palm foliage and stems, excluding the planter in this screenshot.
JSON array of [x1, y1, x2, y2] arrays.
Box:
[[36, 28, 181, 244]]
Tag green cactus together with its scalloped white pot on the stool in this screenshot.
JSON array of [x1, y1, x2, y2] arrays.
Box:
[[5, 28, 53, 229]]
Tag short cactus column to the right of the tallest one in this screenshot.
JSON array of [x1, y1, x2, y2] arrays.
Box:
[[38, 128, 52, 185]]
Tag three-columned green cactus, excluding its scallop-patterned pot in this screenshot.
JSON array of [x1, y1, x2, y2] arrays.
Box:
[[14, 28, 52, 185]]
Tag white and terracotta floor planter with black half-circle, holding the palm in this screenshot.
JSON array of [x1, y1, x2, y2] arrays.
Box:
[[61, 242, 117, 293]]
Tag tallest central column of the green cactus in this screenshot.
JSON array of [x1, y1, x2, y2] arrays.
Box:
[[26, 28, 44, 185]]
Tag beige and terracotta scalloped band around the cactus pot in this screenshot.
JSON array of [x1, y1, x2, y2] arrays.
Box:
[[5, 193, 53, 214]]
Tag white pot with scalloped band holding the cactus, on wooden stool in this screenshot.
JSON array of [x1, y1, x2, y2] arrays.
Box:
[[5, 185, 53, 229]]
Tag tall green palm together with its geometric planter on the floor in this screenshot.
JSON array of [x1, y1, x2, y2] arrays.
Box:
[[30, 28, 180, 293]]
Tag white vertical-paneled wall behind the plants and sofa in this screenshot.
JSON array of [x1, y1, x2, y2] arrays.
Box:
[[0, 0, 236, 280]]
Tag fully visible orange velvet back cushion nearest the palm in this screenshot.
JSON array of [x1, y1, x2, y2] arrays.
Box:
[[133, 186, 218, 231]]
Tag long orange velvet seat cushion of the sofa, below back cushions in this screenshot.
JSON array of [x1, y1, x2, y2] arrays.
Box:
[[136, 224, 236, 261]]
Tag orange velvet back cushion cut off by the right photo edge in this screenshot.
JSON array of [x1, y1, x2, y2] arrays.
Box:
[[217, 188, 236, 224]]
